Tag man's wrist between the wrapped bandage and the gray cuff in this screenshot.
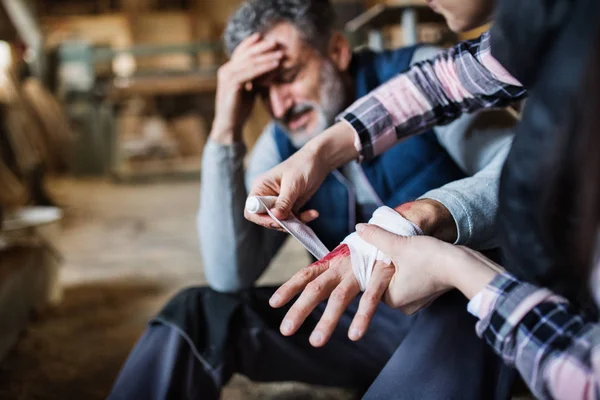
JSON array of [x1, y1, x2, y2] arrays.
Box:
[[396, 199, 458, 243]]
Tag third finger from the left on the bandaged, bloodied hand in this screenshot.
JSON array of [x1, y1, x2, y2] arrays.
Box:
[[309, 276, 360, 347]]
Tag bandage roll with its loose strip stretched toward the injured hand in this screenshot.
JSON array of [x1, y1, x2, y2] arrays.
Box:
[[246, 196, 329, 260]]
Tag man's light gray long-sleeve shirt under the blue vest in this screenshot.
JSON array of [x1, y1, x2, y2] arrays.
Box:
[[197, 47, 515, 292]]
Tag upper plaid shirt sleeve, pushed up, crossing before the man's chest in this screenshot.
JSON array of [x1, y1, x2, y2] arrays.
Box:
[[339, 33, 526, 160]]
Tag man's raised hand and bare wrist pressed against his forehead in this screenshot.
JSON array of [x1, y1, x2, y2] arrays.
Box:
[[210, 33, 283, 144]]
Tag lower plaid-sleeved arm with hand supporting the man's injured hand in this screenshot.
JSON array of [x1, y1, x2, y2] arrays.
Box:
[[358, 225, 600, 400]]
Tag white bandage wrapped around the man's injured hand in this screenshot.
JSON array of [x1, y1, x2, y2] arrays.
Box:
[[342, 207, 423, 292]]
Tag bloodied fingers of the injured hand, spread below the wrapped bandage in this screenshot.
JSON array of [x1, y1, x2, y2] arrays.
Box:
[[269, 244, 394, 347]]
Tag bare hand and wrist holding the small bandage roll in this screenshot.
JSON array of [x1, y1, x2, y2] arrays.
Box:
[[244, 122, 358, 228]]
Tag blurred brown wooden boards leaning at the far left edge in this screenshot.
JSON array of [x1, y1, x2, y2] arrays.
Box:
[[0, 55, 71, 216]]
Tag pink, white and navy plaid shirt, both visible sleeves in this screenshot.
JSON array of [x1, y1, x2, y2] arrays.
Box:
[[340, 33, 600, 400]]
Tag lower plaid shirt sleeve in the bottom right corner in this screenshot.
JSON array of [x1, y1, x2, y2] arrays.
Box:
[[468, 274, 600, 400]]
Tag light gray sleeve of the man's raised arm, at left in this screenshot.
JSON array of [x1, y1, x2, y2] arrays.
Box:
[[197, 126, 286, 292]]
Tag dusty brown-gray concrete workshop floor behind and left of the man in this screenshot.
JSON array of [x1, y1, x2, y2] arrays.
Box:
[[0, 180, 351, 400]]
